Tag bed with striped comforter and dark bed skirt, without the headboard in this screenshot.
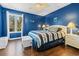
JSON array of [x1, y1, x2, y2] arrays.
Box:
[[28, 24, 66, 51]]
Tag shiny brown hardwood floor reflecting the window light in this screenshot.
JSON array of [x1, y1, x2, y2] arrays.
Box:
[[0, 40, 79, 56]]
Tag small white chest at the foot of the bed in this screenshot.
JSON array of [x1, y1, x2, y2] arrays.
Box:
[[22, 36, 32, 48]]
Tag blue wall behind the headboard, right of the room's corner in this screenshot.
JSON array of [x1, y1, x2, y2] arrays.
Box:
[[45, 3, 79, 27]]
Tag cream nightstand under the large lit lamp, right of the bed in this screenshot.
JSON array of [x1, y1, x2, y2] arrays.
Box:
[[65, 34, 79, 49]]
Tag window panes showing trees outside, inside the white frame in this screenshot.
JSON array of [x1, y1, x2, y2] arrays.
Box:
[[9, 14, 22, 32]]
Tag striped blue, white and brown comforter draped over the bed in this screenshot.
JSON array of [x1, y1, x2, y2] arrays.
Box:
[[28, 30, 65, 48]]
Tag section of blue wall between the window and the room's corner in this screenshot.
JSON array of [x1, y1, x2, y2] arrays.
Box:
[[23, 14, 45, 35]]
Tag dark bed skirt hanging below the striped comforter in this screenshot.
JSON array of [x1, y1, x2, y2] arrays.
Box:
[[32, 38, 65, 51]]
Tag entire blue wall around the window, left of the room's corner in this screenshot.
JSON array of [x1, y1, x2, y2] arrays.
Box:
[[0, 6, 45, 38]]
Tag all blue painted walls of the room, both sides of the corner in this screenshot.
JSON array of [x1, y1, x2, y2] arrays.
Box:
[[0, 3, 79, 37]]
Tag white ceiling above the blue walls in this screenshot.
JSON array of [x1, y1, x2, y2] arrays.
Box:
[[1, 3, 70, 16]]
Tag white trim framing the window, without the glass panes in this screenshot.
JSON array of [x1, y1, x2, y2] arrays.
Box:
[[6, 11, 23, 39]]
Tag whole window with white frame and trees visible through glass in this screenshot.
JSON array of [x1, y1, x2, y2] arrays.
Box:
[[7, 11, 23, 38]]
